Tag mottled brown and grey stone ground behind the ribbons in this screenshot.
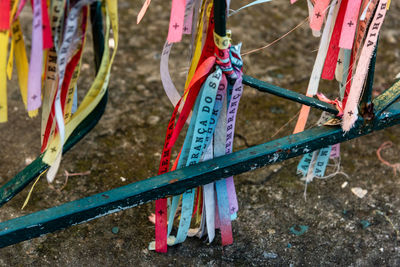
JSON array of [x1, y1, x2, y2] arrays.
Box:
[[0, 0, 400, 266]]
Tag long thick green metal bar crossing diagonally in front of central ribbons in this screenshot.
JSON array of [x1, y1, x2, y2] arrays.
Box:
[[0, 103, 400, 247]]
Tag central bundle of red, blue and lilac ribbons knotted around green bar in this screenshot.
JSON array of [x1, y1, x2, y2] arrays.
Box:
[[150, 0, 243, 252]]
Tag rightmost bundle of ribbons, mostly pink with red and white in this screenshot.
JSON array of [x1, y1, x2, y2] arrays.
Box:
[[291, 0, 390, 184]]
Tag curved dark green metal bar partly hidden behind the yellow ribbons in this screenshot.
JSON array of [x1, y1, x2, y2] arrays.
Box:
[[0, 2, 108, 207]]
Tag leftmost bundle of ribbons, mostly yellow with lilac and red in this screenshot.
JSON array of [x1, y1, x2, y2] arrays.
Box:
[[0, 0, 118, 182]]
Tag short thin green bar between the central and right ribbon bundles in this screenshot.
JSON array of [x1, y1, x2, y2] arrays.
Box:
[[243, 75, 338, 115]]
